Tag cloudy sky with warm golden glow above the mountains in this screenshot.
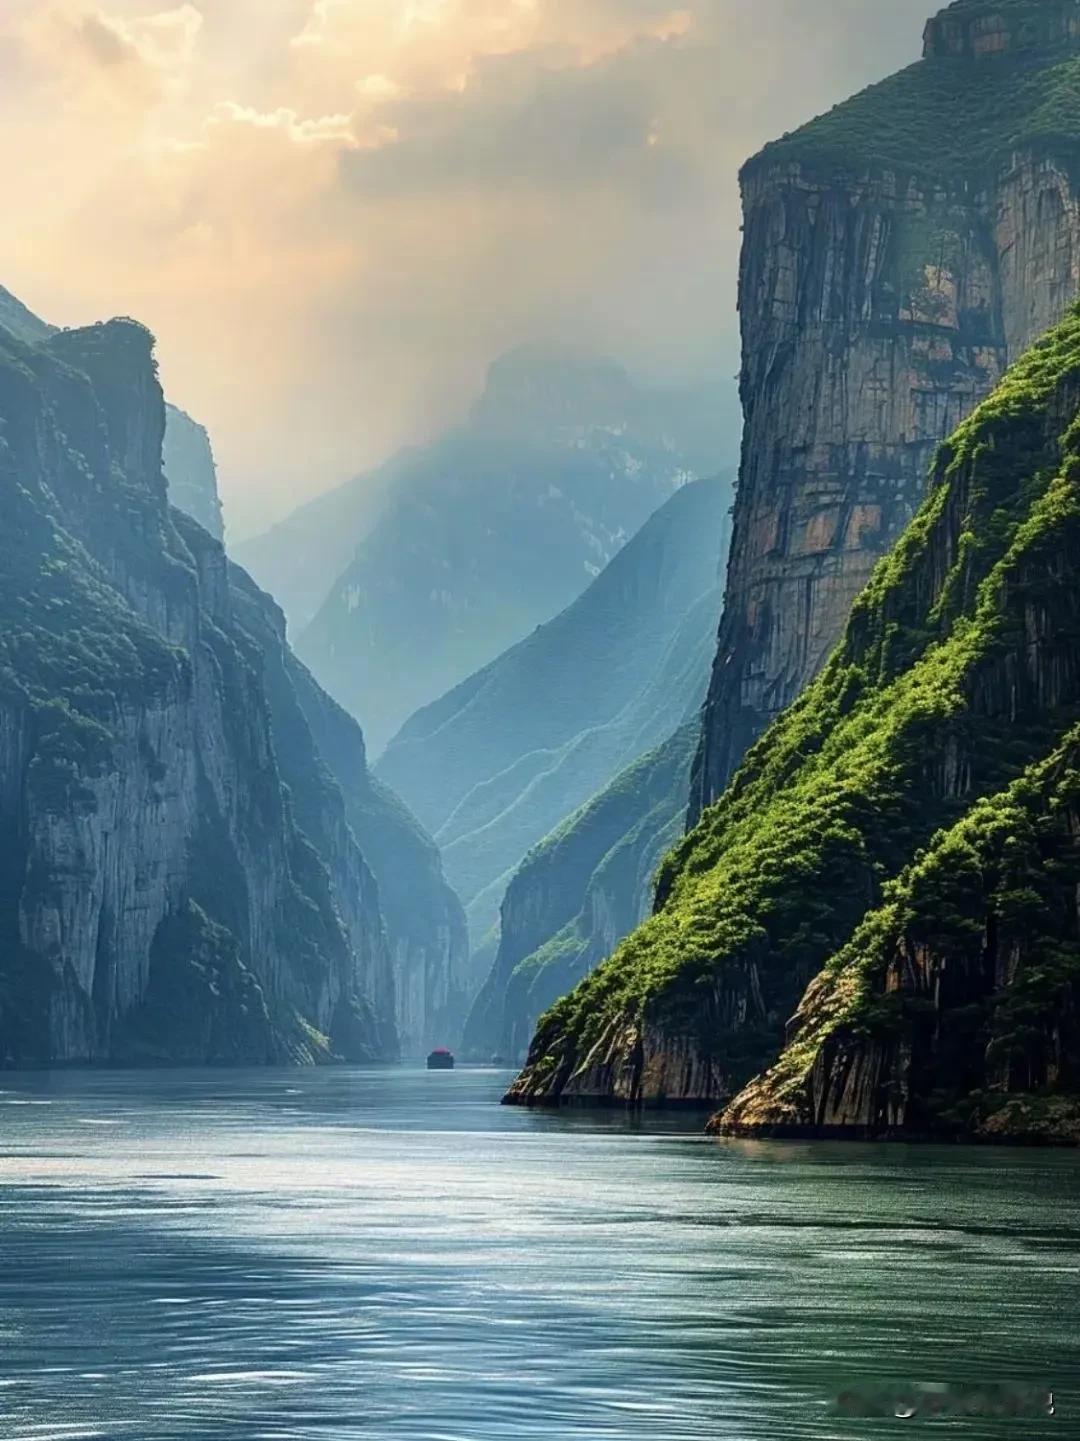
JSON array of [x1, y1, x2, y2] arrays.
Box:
[[0, 0, 933, 536]]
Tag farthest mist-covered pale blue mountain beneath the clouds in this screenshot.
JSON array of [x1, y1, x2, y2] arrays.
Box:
[[279, 347, 730, 752]]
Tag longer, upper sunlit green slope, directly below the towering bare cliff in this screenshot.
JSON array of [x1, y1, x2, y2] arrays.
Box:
[[512, 313, 1080, 1135]]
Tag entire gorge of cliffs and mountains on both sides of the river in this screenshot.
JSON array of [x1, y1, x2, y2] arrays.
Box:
[[0, 0, 1080, 1136]]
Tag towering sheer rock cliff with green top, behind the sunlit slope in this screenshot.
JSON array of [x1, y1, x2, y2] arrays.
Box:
[[692, 0, 1080, 818]]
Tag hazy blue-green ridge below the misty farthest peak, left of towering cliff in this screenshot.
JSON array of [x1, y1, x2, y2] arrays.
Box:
[[375, 480, 731, 944]]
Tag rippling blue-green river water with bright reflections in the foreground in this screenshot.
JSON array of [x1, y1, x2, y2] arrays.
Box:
[[0, 1069, 1080, 1441]]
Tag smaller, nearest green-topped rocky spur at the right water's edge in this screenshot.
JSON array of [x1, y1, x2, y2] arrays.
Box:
[[721, 728, 1080, 1140]]
